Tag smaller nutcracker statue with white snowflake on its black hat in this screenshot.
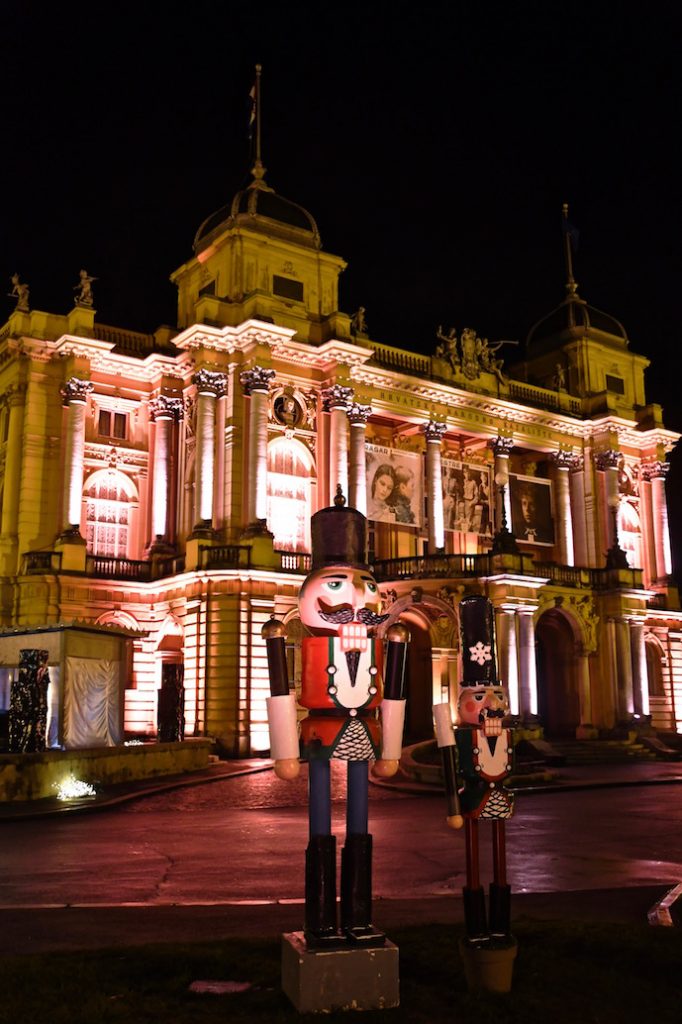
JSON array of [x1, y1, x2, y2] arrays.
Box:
[[433, 596, 516, 953]]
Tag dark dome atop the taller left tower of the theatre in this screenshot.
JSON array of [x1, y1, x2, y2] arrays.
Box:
[[194, 166, 322, 253]]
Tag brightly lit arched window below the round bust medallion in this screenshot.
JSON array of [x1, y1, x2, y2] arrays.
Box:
[[266, 437, 312, 554]]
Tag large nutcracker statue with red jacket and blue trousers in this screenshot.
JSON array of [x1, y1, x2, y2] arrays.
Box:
[[262, 488, 409, 950]]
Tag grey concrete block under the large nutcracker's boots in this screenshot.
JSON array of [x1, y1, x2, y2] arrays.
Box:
[[282, 932, 400, 1013]]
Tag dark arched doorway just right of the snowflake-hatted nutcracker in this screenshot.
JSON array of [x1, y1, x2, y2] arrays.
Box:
[[536, 608, 580, 737]]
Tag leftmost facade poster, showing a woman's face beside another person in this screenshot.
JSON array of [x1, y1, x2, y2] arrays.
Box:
[[365, 444, 423, 526]]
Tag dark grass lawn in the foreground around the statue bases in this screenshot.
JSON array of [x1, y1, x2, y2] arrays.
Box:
[[0, 918, 682, 1024]]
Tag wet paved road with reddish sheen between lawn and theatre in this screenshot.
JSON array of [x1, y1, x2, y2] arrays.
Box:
[[0, 772, 682, 908]]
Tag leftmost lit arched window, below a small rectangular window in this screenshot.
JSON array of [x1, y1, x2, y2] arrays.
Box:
[[83, 469, 136, 558]]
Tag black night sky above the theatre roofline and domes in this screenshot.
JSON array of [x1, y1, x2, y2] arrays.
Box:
[[5, 0, 682, 568]]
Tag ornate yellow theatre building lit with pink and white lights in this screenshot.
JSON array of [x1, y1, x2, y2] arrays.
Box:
[[0, 168, 682, 756]]
